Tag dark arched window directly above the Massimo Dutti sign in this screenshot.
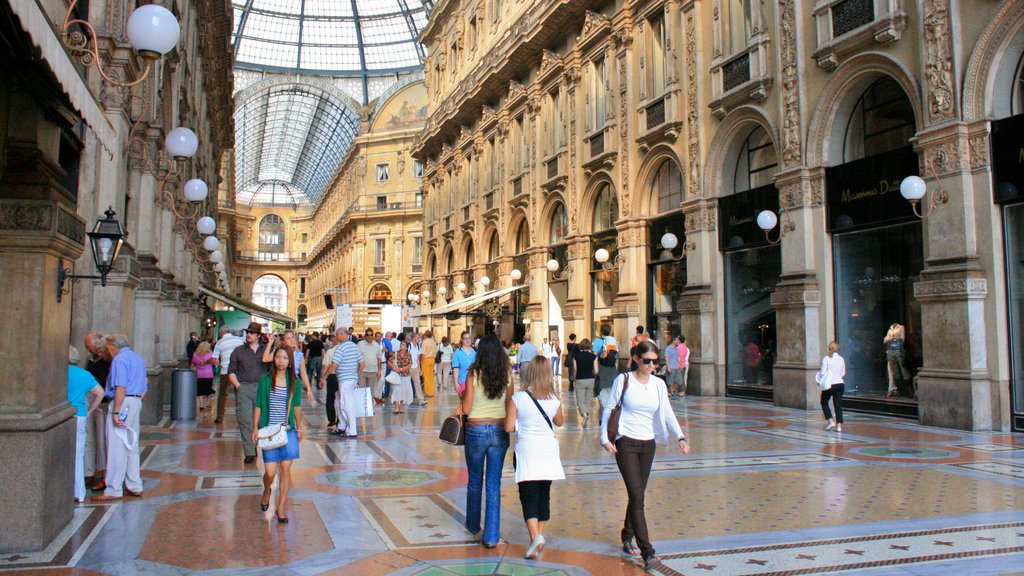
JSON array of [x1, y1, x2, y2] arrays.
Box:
[[843, 76, 914, 162]]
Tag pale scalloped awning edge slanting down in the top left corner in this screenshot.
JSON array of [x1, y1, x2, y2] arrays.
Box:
[[10, 0, 121, 155]]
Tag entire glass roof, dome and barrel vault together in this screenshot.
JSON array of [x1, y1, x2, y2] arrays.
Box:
[[231, 0, 432, 207]]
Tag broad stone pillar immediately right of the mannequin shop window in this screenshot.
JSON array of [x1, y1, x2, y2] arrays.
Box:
[[913, 123, 1011, 430]]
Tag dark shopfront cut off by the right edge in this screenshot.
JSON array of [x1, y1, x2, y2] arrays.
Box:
[[992, 114, 1024, 430]]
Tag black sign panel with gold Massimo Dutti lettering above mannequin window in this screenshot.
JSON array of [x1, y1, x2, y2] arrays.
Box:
[[825, 147, 919, 233]]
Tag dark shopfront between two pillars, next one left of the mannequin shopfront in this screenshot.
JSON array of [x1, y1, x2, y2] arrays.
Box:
[[719, 184, 782, 401]]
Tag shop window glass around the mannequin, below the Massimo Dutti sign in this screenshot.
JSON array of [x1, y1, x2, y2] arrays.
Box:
[[835, 221, 925, 400]]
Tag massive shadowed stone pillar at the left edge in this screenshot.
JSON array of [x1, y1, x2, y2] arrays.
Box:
[[0, 87, 86, 552]]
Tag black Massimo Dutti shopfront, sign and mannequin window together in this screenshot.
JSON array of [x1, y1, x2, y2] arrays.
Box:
[[825, 147, 924, 416]]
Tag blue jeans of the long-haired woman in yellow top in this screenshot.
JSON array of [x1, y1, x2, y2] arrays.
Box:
[[466, 425, 509, 545]]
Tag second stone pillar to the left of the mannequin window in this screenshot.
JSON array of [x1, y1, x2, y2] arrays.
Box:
[[679, 197, 725, 396]]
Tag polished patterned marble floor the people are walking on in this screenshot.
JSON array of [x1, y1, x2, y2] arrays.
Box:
[[0, 385, 1024, 576]]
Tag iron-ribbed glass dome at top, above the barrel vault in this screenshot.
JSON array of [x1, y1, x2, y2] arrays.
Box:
[[231, 0, 431, 78]]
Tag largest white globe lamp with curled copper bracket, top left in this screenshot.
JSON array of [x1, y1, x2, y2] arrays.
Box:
[[60, 0, 181, 88]]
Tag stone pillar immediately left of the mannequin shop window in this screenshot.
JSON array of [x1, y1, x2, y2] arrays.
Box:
[[771, 169, 831, 409]]
